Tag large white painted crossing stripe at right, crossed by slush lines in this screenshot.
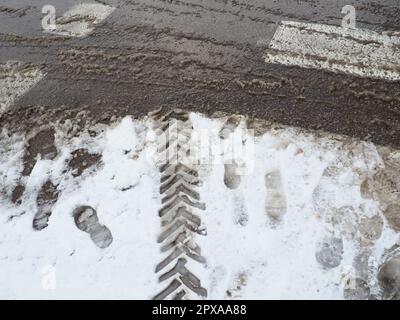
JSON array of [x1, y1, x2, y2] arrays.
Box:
[[265, 21, 400, 81]]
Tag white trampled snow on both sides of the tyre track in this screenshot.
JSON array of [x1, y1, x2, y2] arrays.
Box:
[[0, 113, 400, 299]]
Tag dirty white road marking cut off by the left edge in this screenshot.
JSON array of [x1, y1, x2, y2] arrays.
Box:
[[0, 61, 45, 115]]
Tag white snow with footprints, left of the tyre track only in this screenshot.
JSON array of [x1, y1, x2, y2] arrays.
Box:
[[0, 119, 160, 299]]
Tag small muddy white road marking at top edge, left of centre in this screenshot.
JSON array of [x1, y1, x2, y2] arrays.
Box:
[[45, 3, 115, 38]]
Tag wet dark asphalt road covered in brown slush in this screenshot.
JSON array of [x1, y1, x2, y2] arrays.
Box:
[[0, 0, 400, 146]]
